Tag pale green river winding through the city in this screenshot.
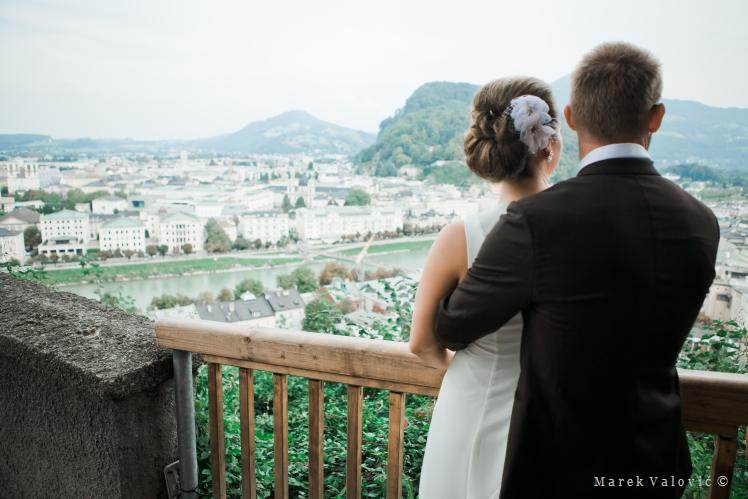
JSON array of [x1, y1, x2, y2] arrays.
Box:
[[64, 249, 428, 311]]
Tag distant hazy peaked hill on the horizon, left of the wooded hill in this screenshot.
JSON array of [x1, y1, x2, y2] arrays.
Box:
[[196, 111, 374, 155]]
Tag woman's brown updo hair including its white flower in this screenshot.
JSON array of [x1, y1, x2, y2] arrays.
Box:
[[464, 77, 559, 182]]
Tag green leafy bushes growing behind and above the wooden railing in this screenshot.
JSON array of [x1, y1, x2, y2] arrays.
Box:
[[196, 282, 748, 498]]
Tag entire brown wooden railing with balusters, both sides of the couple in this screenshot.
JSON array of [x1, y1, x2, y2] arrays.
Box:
[[156, 319, 748, 499]]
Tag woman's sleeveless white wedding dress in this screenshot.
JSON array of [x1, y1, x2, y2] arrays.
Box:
[[419, 206, 522, 499]]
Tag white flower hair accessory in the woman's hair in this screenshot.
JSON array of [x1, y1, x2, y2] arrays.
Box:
[[505, 95, 558, 154]]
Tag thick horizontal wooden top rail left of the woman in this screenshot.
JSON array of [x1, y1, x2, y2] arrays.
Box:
[[156, 319, 444, 395]]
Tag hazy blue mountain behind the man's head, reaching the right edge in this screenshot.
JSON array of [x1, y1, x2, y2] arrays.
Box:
[[552, 76, 748, 169]]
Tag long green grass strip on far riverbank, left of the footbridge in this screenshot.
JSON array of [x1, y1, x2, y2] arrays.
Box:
[[47, 256, 302, 284]]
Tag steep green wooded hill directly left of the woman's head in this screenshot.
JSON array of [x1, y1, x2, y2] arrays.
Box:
[[356, 81, 478, 175]]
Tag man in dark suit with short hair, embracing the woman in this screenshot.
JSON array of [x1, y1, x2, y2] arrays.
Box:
[[436, 43, 719, 499]]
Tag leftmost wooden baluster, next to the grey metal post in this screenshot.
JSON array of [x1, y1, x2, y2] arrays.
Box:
[[208, 363, 226, 499]]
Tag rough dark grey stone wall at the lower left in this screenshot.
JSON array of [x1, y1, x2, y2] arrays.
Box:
[[0, 273, 177, 498]]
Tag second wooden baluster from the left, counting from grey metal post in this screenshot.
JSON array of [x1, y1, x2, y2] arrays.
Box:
[[239, 367, 257, 499]]
